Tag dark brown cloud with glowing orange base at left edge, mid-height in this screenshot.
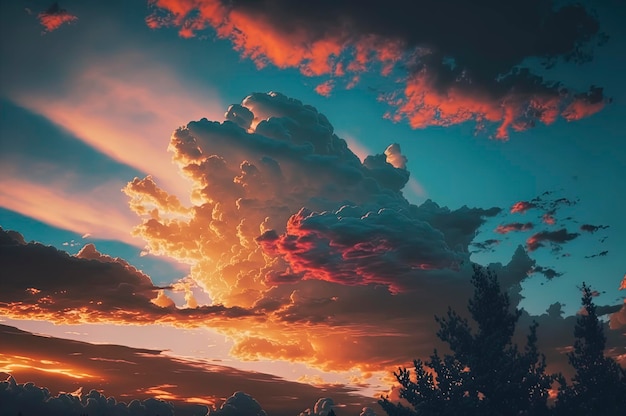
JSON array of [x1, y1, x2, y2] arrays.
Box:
[[0, 228, 252, 324]]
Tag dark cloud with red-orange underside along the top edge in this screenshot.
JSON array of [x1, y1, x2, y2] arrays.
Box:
[[146, 0, 607, 139]]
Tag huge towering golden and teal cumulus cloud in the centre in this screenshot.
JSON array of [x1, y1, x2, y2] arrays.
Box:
[[125, 93, 544, 371]]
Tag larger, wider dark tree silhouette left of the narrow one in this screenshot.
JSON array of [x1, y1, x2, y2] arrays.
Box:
[[379, 266, 556, 416]]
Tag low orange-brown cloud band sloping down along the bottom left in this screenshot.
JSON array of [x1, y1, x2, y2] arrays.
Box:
[[0, 325, 375, 414]]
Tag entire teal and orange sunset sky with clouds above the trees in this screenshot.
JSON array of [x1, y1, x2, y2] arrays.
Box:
[[0, 0, 626, 416]]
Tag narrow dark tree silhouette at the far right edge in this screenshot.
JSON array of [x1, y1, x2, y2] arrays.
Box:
[[556, 283, 626, 416]]
